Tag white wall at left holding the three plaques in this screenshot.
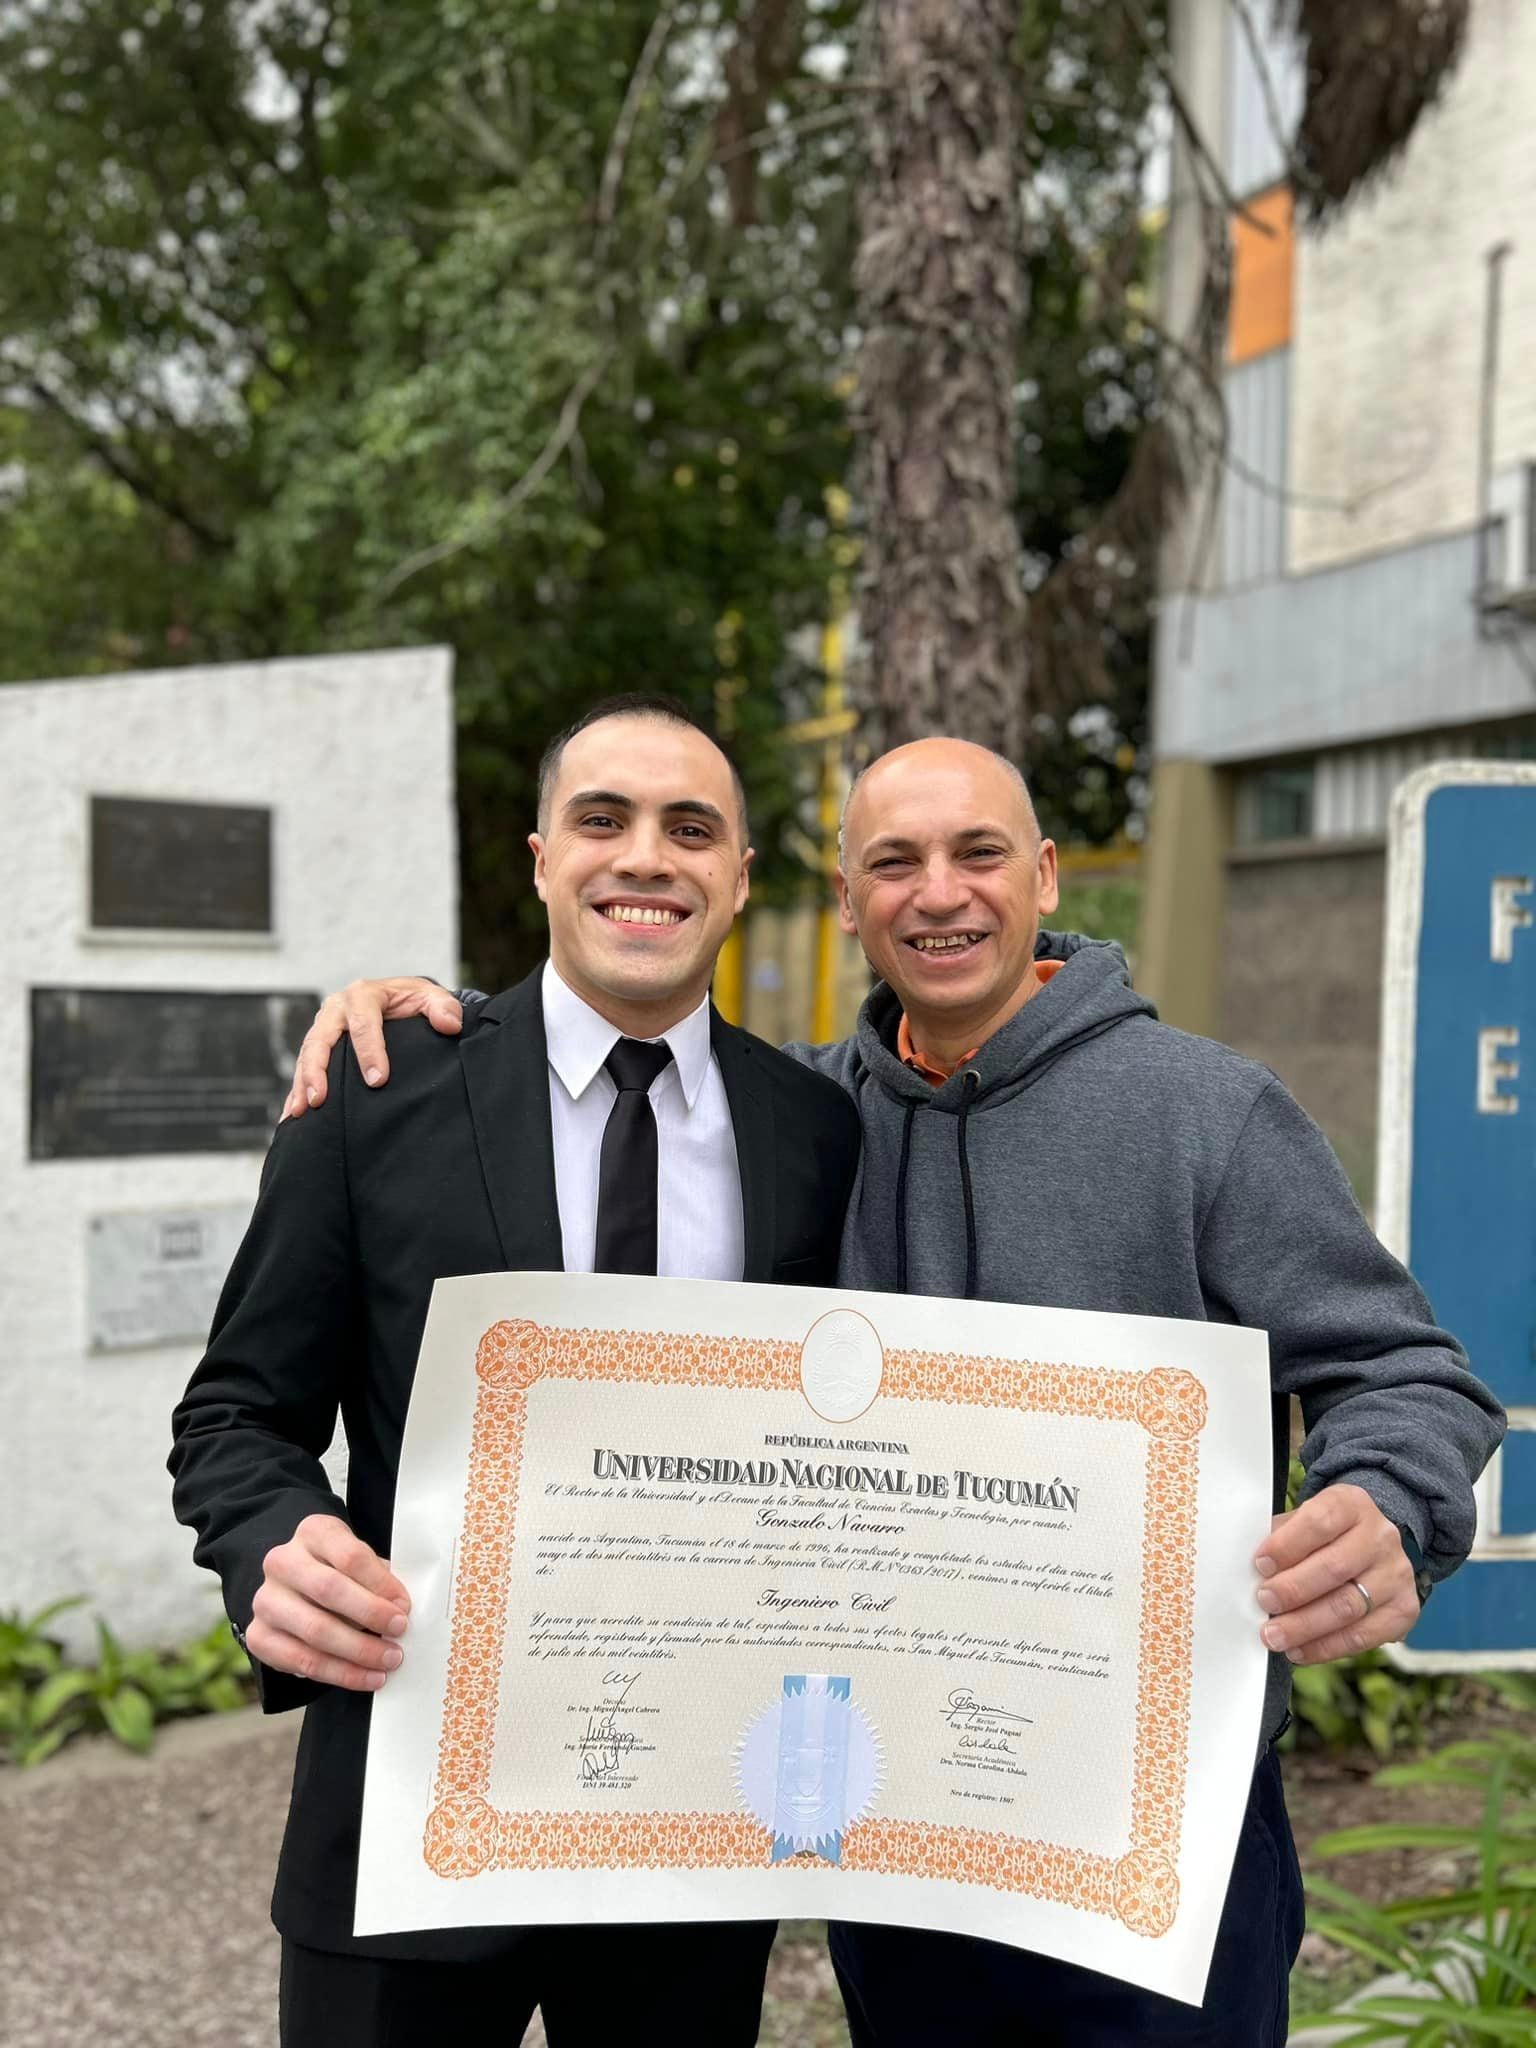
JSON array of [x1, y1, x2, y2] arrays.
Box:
[[0, 649, 459, 1642]]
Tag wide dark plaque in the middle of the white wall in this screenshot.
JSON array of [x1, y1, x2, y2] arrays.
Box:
[[31, 989, 317, 1159]]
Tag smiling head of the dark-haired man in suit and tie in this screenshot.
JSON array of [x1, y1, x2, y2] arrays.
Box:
[[528, 715, 752, 1036]]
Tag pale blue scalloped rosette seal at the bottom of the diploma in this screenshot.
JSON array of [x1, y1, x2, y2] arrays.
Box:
[[735, 1671, 883, 1864]]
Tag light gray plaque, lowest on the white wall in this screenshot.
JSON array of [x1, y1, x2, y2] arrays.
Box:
[[86, 1204, 250, 1352]]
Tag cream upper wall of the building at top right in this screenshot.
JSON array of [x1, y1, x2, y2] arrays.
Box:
[[1288, 0, 1536, 571]]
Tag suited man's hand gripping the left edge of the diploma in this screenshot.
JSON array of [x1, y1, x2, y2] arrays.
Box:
[[244, 1516, 410, 1692]]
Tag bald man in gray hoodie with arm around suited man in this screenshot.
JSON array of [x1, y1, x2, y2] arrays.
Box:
[[291, 739, 1503, 2048]]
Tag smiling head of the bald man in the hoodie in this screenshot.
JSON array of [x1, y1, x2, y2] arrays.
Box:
[[840, 739, 1057, 1047]]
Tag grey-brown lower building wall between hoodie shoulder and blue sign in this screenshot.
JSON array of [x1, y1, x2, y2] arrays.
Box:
[[1217, 840, 1386, 1206]]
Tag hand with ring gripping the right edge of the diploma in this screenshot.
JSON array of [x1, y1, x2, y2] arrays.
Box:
[[1253, 1485, 1419, 1663]]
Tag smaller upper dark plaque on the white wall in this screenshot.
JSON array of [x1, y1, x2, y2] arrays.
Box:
[[90, 797, 272, 932]]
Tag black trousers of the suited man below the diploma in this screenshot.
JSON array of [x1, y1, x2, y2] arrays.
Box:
[[279, 1921, 774, 2048]]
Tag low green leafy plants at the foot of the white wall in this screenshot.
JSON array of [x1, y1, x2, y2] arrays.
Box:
[[0, 1599, 252, 1765]]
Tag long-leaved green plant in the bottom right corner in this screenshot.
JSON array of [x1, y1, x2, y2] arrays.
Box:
[[1292, 1673, 1536, 2048]]
